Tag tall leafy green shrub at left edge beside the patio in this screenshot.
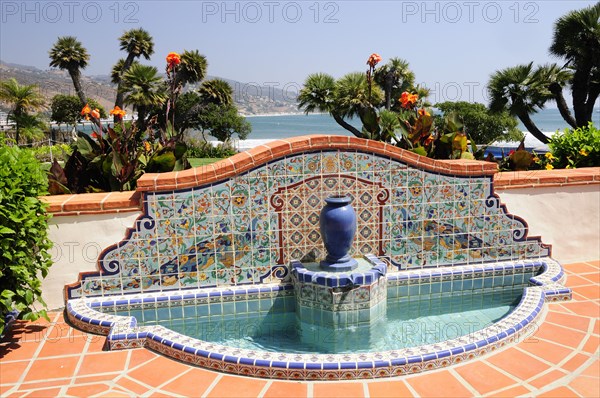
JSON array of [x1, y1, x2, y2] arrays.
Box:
[[0, 139, 52, 335]]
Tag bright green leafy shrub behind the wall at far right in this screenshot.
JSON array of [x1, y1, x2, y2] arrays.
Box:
[[548, 123, 600, 168]]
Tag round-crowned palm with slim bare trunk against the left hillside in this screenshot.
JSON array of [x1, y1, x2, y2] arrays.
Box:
[[49, 36, 90, 108]]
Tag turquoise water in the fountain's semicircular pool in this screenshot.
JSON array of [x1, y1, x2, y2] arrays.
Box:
[[110, 286, 523, 354]]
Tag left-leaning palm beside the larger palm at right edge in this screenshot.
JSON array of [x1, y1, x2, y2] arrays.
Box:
[[488, 63, 552, 143]]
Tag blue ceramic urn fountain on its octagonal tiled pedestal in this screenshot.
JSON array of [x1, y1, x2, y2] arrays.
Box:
[[290, 195, 387, 346]]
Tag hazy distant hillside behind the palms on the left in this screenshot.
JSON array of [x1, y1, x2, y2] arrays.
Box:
[[0, 60, 298, 115]]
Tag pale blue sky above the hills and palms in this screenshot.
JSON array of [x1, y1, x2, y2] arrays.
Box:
[[0, 0, 595, 103]]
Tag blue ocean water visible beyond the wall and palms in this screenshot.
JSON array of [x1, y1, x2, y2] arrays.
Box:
[[236, 108, 600, 150]]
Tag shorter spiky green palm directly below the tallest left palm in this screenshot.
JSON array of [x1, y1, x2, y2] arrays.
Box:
[[122, 64, 167, 132]]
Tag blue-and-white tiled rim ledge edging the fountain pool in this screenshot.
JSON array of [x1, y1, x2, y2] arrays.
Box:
[[66, 258, 571, 380]]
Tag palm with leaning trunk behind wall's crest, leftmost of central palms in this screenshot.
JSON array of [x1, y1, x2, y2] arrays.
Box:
[[298, 73, 363, 137]]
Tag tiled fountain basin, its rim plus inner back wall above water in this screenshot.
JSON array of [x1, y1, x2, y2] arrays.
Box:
[[66, 258, 571, 380]]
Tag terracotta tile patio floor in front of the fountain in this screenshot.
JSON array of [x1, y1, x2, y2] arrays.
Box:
[[0, 261, 600, 397]]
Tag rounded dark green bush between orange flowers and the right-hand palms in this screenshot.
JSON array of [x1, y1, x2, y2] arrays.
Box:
[[435, 101, 523, 145]]
